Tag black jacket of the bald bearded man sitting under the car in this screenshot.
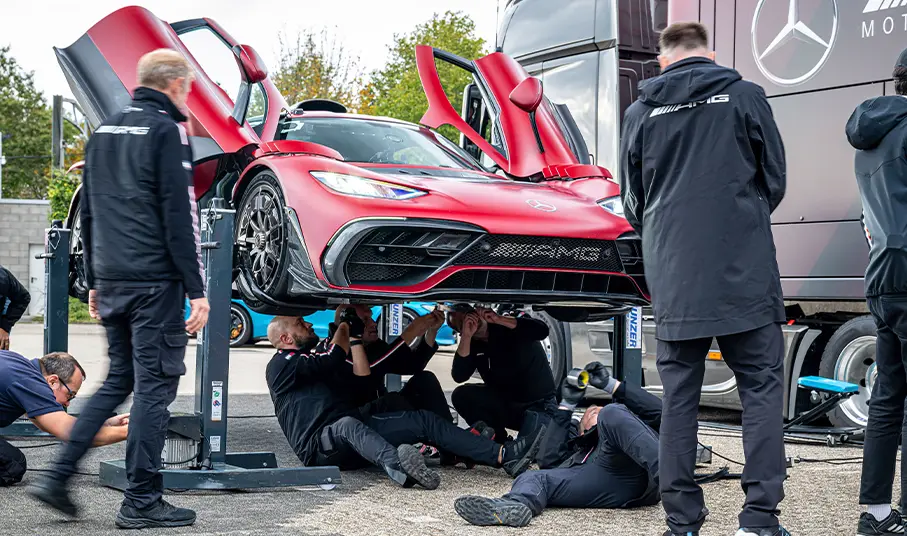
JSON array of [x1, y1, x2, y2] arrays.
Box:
[[265, 346, 360, 465]]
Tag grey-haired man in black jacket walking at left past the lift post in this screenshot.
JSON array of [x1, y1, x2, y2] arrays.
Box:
[[32, 49, 208, 528]]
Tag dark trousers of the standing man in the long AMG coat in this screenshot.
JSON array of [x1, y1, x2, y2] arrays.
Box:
[[657, 324, 787, 534]]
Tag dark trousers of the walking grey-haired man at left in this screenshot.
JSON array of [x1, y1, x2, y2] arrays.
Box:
[[54, 281, 188, 508]]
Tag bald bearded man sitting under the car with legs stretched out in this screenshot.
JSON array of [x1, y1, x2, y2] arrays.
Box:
[[266, 315, 545, 489]]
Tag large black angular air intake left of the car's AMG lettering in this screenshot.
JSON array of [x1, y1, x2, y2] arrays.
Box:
[[346, 227, 477, 285]]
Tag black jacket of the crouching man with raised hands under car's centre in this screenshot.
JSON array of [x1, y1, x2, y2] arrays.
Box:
[[451, 317, 555, 403]]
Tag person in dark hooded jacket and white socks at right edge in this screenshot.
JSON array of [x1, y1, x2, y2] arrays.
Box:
[[846, 50, 907, 536]]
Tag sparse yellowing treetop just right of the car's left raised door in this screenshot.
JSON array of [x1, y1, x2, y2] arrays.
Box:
[[272, 29, 365, 109]]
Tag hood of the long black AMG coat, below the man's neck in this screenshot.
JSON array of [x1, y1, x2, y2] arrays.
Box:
[[639, 57, 743, 106]]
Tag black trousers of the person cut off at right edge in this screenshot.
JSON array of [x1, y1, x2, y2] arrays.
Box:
[[860, 294, 907, 511]]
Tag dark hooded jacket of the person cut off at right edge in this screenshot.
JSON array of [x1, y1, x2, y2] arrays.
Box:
[[846, 96, 907, 297]]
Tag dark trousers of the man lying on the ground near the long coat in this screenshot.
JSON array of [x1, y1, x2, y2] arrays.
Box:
[[504, 385, 661, 515]]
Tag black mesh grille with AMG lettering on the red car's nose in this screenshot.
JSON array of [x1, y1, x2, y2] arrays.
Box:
[[455, 235, 623, 272]]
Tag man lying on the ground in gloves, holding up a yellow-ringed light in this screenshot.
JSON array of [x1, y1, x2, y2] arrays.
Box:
[[454, 362, 661, 527]]
